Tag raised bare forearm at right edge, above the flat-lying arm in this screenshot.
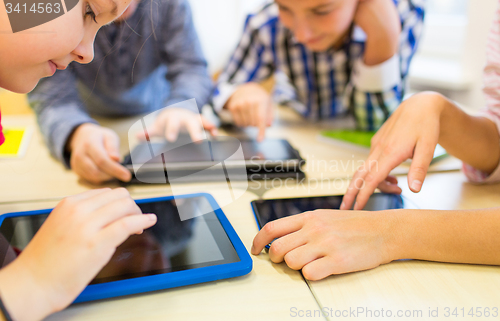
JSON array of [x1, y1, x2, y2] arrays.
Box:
[[439, 96, 500, 173]]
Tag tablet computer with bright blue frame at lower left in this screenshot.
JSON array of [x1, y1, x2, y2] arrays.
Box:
[[0, 194, 252, 302]]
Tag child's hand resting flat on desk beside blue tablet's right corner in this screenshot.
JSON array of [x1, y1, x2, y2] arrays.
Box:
[[252, 210, 396, 280]]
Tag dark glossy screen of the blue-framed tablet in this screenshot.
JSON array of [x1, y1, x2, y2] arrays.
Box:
[[0, 197, 240, 284]]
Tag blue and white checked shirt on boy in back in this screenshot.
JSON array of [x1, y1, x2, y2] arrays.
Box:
[[213, 0, 425, 130]]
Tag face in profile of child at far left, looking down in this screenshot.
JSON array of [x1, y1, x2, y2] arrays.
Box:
[[0, 0, 130, 93]]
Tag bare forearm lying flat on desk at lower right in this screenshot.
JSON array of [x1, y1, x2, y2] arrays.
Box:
[[392, 208, 500, 265]]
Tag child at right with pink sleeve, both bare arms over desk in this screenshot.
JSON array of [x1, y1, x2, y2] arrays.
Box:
[[252, 3, 500, 280]]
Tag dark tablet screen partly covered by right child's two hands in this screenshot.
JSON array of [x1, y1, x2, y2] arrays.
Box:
[[252, 194, 404, 228]]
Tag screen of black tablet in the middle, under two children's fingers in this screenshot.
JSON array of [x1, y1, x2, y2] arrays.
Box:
[[126, 139, 297, 165]]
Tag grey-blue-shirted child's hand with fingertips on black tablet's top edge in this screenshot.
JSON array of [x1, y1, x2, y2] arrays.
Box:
[[141, 108, 217, 142]]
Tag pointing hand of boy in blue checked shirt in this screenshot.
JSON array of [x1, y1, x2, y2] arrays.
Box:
[[224, 83, 274, 141]]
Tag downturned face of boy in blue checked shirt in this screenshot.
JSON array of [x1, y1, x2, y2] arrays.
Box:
[[275, 0, 359, 52]]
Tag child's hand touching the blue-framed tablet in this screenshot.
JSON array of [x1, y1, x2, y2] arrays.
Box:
[[0, 189, 156, 320]]
